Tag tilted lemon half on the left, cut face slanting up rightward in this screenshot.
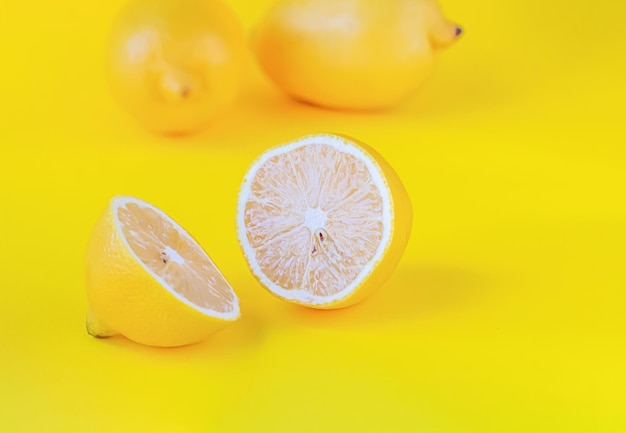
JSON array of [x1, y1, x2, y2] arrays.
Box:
[[86, 197, 239, 347]]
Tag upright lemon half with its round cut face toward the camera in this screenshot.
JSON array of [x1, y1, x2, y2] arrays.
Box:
[[237, 135, 412, 308]]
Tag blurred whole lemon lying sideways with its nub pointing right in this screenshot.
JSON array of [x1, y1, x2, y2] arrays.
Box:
[[252, 0, 461, 110]]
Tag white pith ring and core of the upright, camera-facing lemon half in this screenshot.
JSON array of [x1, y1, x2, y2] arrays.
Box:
[[237, 135, 393, 305]]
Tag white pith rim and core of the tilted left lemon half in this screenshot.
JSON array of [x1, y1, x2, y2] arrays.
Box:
[[112, 197, 240, 320]]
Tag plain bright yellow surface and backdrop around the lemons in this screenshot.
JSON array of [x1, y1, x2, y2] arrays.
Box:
[[0, 0, 626, 433]]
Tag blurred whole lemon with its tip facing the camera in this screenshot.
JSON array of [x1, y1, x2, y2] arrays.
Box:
[[107, 0, 246, 134]]
